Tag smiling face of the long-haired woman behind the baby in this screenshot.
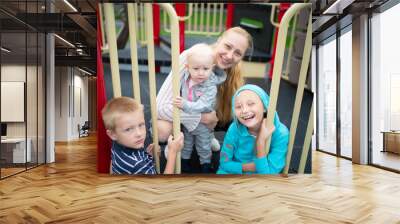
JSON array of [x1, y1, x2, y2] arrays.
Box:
[[215, 31, 248, 69]]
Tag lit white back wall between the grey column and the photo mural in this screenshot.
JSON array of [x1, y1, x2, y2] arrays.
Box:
[[55, 67, 88, 141]]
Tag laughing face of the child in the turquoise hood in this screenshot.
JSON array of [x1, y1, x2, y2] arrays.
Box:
[[234, 90, 264, 134]]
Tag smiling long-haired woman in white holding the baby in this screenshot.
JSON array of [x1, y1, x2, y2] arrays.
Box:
[[157, 27, 253, 168]]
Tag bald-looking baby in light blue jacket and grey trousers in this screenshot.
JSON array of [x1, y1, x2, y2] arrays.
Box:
[[173, 43, 225, 173]]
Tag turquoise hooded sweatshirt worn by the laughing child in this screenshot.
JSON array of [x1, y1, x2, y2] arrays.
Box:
[[217, 84, 289, 174]]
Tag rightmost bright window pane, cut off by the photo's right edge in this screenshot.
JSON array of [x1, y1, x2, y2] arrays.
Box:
[[370, 4, 400, 170]]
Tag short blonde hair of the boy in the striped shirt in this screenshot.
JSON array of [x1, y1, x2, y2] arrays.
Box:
[[101, 96, 143, 131]]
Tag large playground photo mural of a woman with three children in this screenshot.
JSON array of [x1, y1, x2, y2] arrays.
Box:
[[97, 3, 315, 175]]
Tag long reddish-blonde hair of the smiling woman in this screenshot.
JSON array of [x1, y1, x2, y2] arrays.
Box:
[[216, 27, 253, 125]]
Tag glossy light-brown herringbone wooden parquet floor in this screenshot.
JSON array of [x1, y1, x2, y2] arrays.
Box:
[[0, 134, 400, 224]]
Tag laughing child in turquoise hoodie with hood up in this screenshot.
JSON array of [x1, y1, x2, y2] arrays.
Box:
[[217, 84, 289, 174]]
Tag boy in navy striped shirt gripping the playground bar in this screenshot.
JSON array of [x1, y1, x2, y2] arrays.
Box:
[[102, 97, 183, 174]]
